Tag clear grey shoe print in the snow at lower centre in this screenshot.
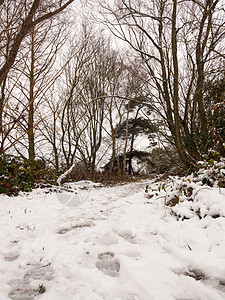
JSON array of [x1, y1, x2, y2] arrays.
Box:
[[95, 252, 120, 277]]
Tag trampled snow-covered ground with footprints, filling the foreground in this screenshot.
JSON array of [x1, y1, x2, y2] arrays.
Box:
[[0, 181, 225, 300]]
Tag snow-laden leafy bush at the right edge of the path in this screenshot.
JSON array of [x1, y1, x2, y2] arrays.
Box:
[[145, 150, 225, 221]]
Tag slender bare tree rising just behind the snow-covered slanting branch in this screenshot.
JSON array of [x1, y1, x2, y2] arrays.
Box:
[[59, 34, 93, 169]]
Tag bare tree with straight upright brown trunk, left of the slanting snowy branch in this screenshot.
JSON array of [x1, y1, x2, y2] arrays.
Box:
[[17, 21, 67, 159]]
